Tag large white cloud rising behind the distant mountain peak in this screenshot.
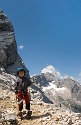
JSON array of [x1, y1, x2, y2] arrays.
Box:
[[41, 65, 68, 79]]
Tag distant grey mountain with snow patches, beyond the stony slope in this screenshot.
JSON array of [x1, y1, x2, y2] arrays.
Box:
[[32, 72, 81, 112]]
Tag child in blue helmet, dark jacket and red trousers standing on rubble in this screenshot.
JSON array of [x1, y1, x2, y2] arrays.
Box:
[[15, 68, 32, 119]]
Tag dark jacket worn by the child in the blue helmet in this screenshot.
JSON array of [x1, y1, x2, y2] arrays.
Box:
[[14, 77, 31, 94]]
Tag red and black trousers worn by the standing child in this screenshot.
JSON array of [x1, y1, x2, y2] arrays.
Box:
[[17, 91, 30, 111]]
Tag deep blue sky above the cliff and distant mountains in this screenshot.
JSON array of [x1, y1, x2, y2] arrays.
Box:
[[0, 0, 81, 82]]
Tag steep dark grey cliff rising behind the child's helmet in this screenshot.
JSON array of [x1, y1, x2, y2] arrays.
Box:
[[0, 10, 29, 75]]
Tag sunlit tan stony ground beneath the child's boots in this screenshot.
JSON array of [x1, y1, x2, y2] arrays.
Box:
[[0, 89, 81, 125]]
